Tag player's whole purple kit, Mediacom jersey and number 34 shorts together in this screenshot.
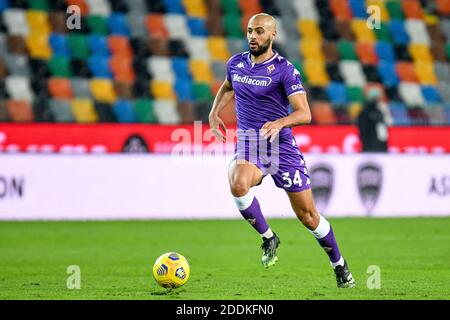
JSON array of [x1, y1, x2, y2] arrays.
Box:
[[227, 52, 311, 192]]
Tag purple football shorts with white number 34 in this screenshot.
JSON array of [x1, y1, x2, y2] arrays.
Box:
[[233, 130, 311, 192]]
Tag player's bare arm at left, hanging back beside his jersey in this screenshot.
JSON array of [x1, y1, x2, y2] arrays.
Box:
[[209, 79, 234, 142]]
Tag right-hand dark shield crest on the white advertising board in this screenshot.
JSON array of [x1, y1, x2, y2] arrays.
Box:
[[356, 162, 383, 213]]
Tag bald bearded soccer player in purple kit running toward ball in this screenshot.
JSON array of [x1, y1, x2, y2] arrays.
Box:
[[209, 13, 355, 288]]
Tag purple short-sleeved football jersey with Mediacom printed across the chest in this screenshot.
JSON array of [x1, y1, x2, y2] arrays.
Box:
[[227, 51, 305, 135]]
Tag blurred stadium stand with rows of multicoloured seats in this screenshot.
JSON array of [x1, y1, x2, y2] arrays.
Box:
[[0, 0, 450, 125]]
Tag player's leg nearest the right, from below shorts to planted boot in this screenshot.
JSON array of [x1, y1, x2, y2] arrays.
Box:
[[287, 189, 355, 288]]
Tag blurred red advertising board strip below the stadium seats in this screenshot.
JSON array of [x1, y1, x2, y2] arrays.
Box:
[[0, 124, 450, 153]]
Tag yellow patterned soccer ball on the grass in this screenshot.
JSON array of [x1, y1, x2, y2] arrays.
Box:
[[153, 252, 190, 289]]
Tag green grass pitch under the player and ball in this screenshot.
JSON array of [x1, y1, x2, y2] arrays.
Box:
[[0, 218, 450, 300]]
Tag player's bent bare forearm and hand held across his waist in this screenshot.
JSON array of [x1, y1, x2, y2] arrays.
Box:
[[261, 93, 311, 142]]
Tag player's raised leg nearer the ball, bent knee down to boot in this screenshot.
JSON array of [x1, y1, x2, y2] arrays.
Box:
[[228, 160, 280, 268]]
